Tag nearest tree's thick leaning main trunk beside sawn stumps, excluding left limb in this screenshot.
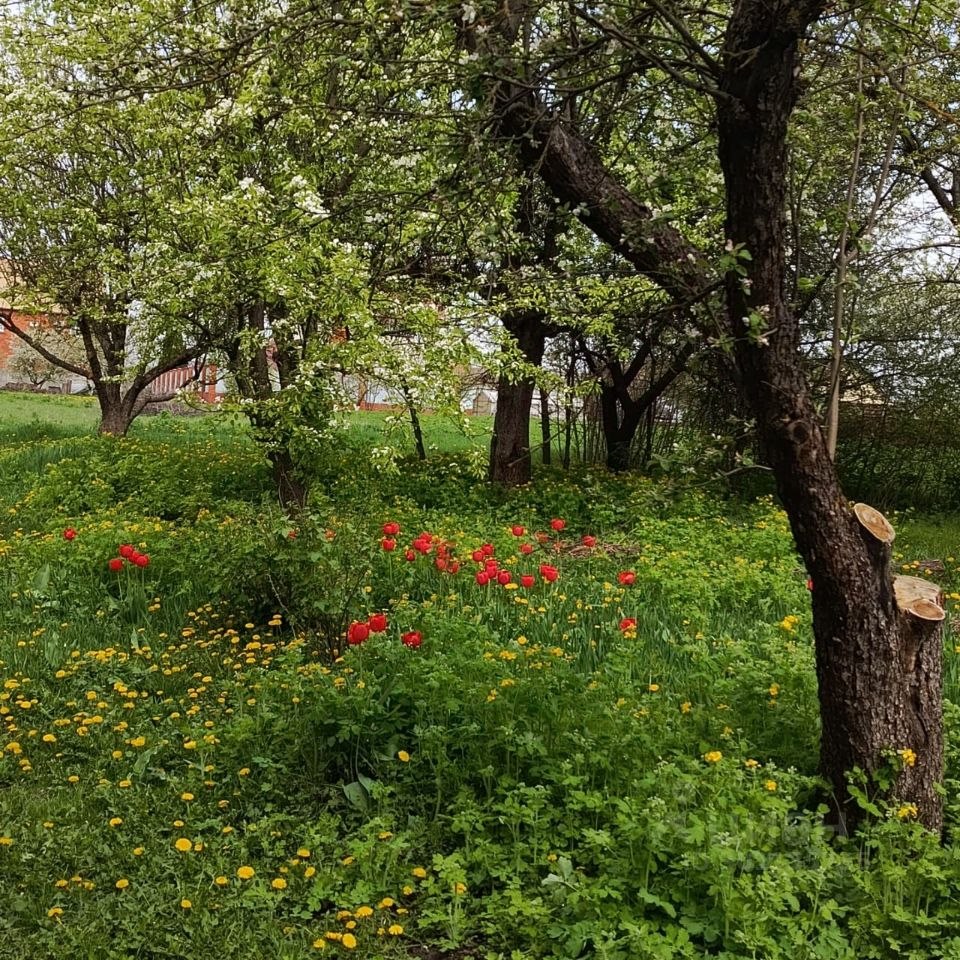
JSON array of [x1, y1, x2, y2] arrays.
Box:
[[717, 0, 943, 831]]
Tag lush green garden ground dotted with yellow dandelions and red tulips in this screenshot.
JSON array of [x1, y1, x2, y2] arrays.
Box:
[[0, 397, 960, 960]]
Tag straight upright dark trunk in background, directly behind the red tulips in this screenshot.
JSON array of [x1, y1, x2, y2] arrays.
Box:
[[490, 310, 546, 487]]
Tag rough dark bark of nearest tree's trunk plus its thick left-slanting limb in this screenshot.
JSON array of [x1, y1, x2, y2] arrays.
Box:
[[488, 0, 943, 830]]
